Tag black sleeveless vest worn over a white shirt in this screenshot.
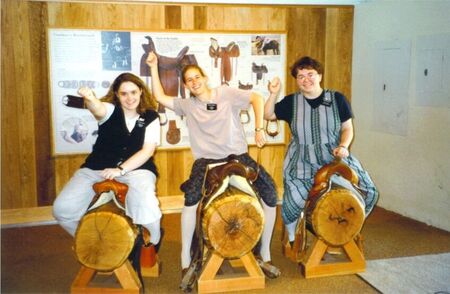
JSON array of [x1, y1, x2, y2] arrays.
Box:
[[81, 106, 158, 175]]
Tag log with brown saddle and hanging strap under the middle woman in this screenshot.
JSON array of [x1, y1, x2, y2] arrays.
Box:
[[180, 159, 264, 291]]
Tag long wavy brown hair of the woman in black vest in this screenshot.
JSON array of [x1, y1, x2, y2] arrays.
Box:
[[102, 73, 157, 114]]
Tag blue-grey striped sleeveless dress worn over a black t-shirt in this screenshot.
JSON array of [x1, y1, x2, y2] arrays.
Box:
[[277, 90, 378, 224]]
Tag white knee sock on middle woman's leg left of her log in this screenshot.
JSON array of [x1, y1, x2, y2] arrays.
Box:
[[181, 203, 198, 269]]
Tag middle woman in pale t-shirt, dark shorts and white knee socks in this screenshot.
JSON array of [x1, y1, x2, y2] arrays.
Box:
[[147, 52, 279, 278]]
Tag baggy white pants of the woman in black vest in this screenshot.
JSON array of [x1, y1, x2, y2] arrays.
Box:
[[53, 168, 162, 236]]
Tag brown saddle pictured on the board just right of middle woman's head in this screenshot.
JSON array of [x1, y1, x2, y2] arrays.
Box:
[[209, 38, 240, 85]]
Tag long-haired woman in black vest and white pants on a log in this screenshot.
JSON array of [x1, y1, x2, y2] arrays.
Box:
[[53, 73, 162, 247]]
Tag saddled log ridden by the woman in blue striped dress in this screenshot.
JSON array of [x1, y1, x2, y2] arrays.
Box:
[[291, 159, 366, 261]]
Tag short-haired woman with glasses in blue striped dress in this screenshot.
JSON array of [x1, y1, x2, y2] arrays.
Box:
[[264, 56, 378, 244]]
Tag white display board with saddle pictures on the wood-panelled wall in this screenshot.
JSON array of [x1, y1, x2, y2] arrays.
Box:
[[48, 28, 286, 155]]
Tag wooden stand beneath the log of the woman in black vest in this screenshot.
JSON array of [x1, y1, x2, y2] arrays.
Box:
[[71, 260, 142, 294]]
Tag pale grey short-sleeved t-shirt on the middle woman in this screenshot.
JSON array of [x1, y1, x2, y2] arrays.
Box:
[[174, 86, 251, 159]]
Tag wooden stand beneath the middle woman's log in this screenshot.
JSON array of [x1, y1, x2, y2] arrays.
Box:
[[197, 251, 265, 294]]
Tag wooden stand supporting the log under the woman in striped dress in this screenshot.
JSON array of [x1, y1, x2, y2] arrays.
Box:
[[302, 239, 366, 279]]
